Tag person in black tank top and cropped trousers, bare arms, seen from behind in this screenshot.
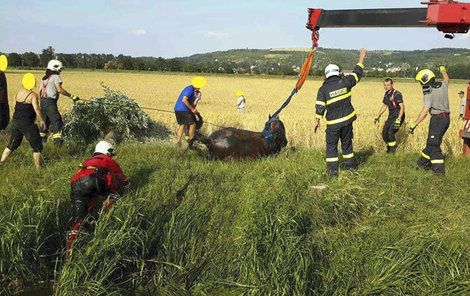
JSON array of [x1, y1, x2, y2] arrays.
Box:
[[0, 73, 44, 169]]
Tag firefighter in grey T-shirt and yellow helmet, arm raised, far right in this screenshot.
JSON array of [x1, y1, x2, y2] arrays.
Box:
[[409, 66, 450, 175]]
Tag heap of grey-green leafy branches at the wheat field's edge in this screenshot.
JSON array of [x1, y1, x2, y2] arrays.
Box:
[[63, 86, 170, 145]]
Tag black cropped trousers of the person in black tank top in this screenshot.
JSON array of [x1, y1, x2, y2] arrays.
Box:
[[7, 120, 42, 152]]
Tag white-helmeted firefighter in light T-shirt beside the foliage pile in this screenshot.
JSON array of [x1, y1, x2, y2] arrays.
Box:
[[39, 60, 80, 147]]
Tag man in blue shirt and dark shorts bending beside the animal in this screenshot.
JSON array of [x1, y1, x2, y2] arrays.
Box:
[[174, 76, 206, 147]]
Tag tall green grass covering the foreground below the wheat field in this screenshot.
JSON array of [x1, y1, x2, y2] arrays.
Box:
[[0, 139, 470, 295]]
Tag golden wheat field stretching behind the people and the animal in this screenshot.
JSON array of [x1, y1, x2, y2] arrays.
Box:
[[2, 71, 466, 154]]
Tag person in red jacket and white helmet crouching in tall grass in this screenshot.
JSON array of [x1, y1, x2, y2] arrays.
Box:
[[67, 141, 129, 250]]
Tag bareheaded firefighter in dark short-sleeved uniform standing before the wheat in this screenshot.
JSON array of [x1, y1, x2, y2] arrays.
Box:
[[374, 78, 405, 153]]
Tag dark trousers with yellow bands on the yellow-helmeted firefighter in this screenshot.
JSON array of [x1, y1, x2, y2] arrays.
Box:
[[417, 115, 450, 175]]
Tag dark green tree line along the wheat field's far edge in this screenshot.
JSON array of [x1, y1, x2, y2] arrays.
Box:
[[1, 46, 470, 79]]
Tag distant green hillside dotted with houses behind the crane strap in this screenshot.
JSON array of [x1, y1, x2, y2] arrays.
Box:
[[179, 48, 470, 78]]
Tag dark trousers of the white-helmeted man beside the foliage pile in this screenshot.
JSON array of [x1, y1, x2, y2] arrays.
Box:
[[41, 98, 64, 145]]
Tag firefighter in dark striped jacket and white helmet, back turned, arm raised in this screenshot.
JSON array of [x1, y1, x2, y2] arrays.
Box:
[[314, 49, 366, 177]]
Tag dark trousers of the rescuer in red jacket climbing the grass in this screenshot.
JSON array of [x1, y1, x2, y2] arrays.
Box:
[[70, 173, 106, 227]]
